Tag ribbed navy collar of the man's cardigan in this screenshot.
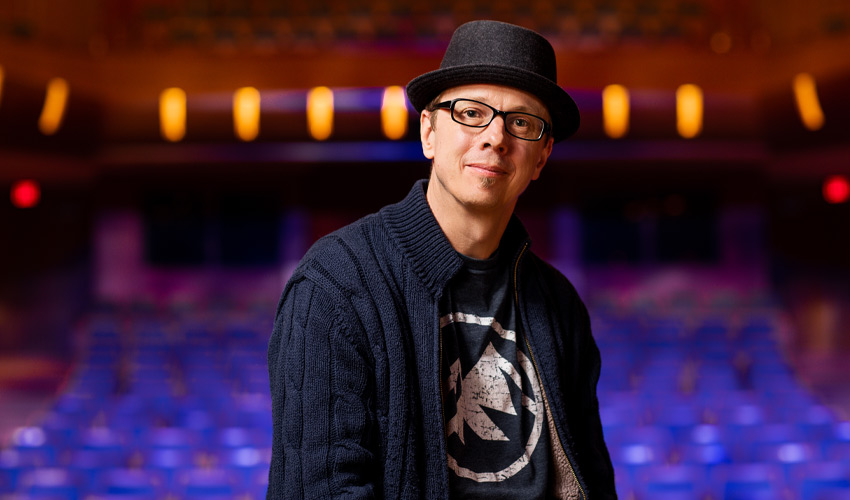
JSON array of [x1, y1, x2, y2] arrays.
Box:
[[380, 179, 530, 297]]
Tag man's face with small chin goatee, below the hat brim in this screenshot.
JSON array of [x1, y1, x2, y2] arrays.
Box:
[[420, 84, 553, 218]]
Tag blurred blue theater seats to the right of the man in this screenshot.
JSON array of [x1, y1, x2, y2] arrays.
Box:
[[592, 305, 850, 500]]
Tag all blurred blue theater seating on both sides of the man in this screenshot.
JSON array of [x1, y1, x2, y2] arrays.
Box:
[[0, 298, 850, 500]]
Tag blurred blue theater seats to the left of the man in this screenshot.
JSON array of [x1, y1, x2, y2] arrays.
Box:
[[0, 308, 273, 500]]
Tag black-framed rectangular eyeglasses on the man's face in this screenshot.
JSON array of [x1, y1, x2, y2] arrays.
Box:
[[436, 99, 551, 141]]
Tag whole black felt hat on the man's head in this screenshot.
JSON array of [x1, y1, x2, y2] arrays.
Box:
[[407, 21, 579, 142]]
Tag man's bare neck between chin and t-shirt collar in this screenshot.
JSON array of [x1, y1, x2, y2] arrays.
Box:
[[426, 179, 513, 259]]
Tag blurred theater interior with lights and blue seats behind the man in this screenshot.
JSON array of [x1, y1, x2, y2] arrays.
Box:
[[0, 0, 850, 500]]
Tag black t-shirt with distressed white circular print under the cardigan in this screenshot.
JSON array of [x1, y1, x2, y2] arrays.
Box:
[[440, 248, 550, 500]]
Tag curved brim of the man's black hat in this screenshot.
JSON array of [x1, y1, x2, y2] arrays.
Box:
[[407, 64, 580, 142]]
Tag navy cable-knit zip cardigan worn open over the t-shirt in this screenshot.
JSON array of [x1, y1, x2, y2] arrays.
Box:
[[268, 181, 616, 500]]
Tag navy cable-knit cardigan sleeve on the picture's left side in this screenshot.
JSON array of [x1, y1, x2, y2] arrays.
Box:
[[267, 277, 379, 499]]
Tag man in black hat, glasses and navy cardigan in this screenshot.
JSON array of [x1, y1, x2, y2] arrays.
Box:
[[268, 21, 616, 500]]
